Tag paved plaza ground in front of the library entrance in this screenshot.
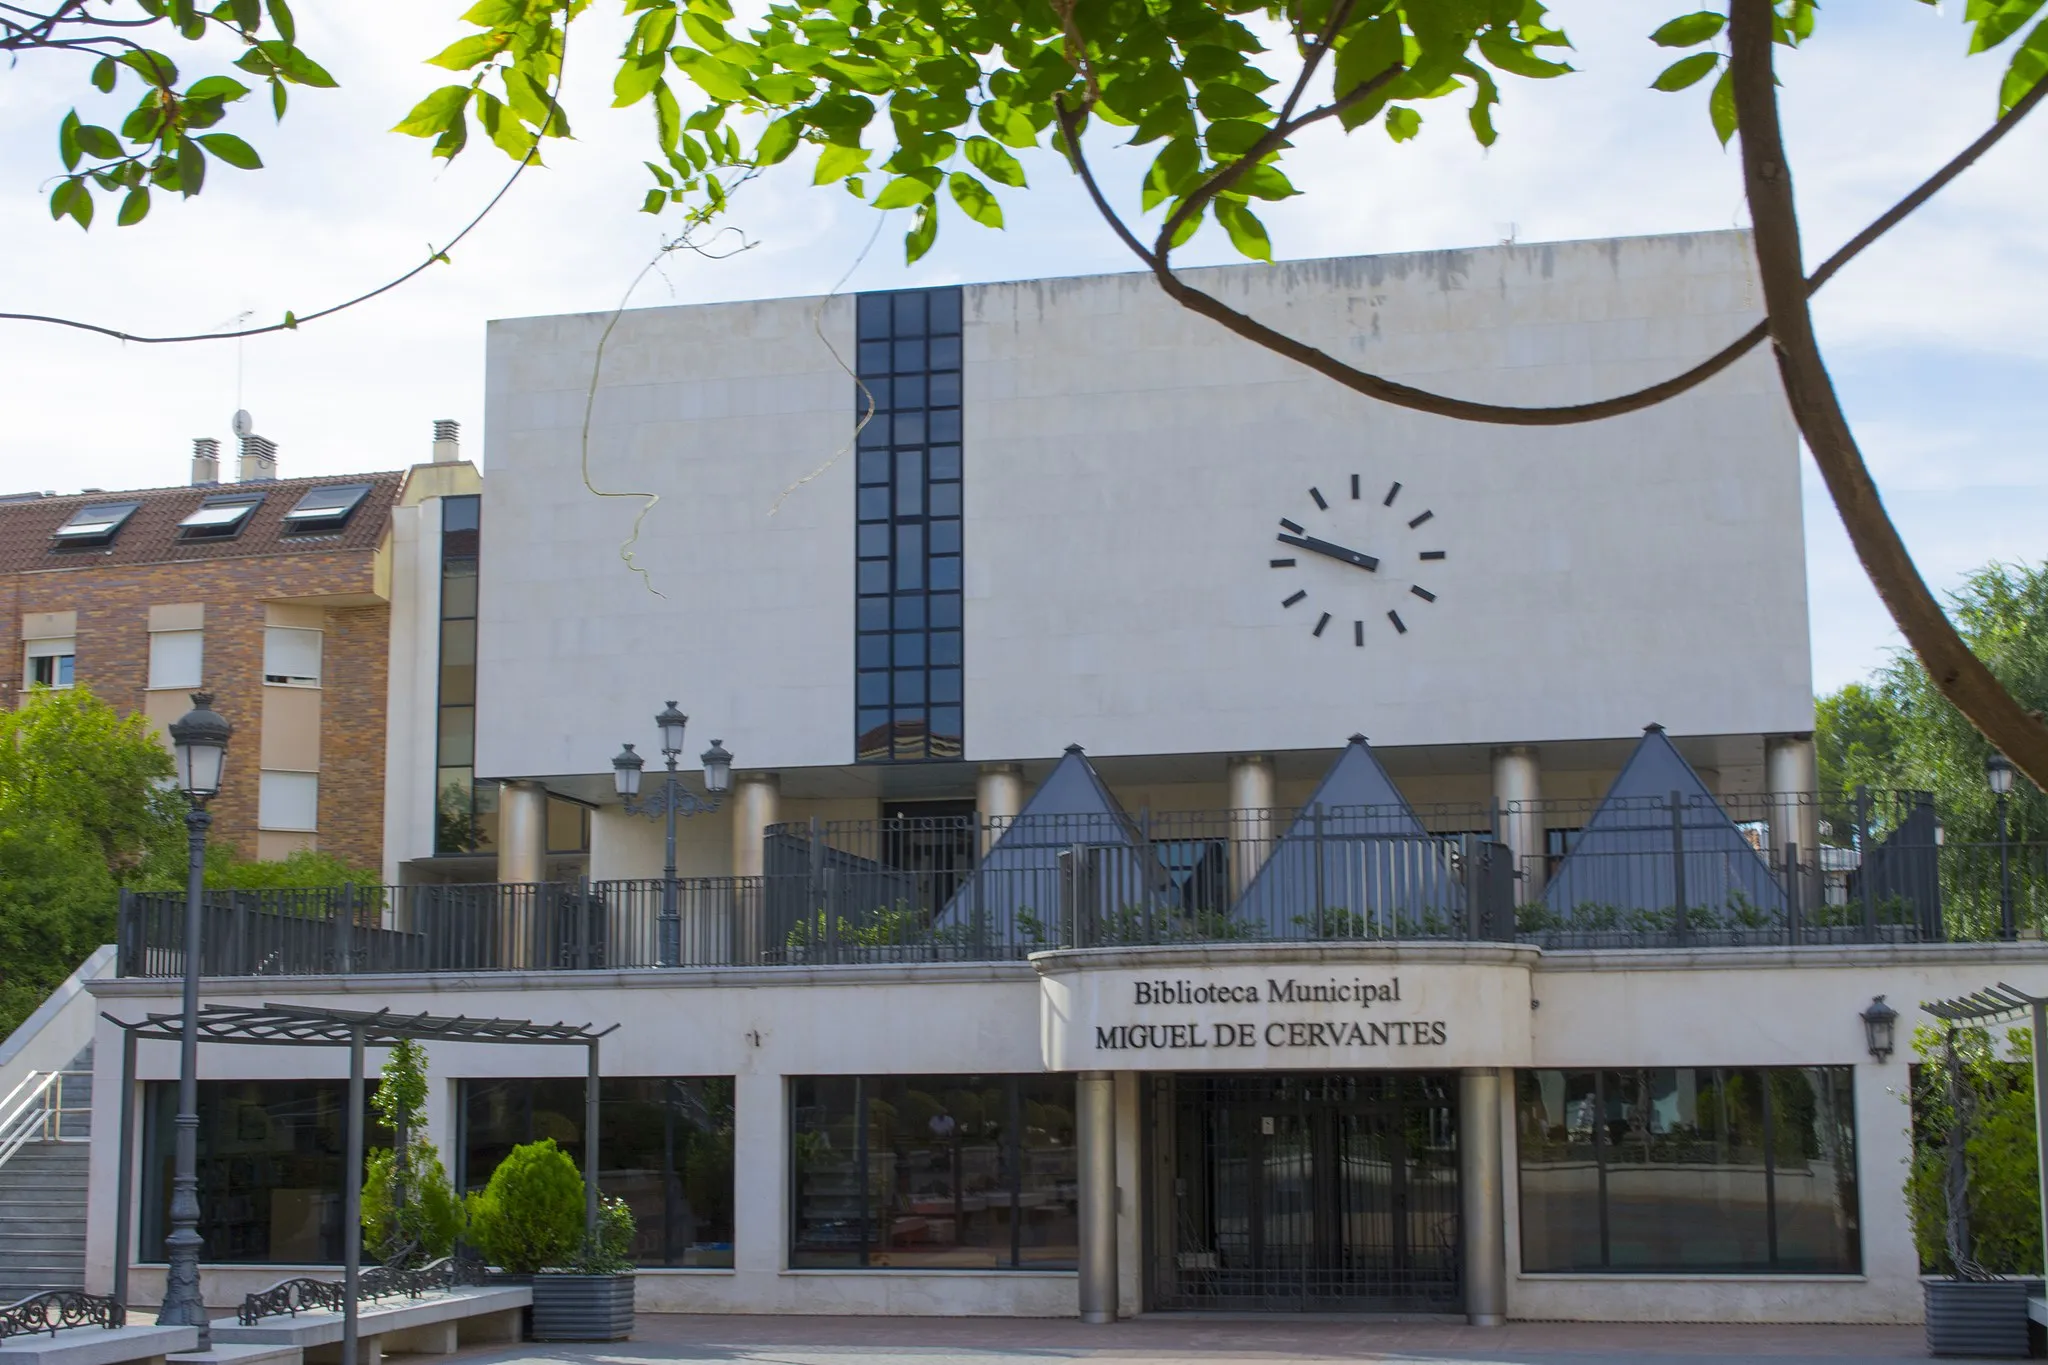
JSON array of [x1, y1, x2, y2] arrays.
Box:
[[448, 1314, 1927, 1365]]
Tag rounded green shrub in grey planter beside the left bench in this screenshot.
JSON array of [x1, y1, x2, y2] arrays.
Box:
[[469, 1138, 633, 1340]]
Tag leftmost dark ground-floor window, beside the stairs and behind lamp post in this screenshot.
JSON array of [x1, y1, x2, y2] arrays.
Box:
[[139, 1081, 391, 1265]]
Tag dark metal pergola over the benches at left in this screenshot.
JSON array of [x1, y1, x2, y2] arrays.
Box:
[[102, 1005, 618, 1365]]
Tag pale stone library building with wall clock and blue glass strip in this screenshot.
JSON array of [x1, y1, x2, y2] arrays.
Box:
[[68, 231, 2048, 1324]]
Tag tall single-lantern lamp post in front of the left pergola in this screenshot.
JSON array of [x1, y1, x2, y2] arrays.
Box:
[[156, 692, 236, 1351]]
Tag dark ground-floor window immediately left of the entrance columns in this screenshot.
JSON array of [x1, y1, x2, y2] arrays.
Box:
[[791, 1076, 1079, 1269]]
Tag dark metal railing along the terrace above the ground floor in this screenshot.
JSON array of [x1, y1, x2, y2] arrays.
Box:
[[119, 792, 2048, 976]]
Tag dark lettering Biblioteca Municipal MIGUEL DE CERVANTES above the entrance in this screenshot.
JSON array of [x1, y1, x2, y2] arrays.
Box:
[[1096, 976, 1448, 1052]]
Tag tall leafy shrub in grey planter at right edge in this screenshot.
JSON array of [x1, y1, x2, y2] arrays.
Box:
[[1907, 1029, 2040, 1357]]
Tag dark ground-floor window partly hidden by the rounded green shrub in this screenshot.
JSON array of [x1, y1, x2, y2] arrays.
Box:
[[457, 1076, 733, 1267]]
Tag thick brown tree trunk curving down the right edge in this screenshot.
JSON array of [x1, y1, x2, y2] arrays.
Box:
[[1729, 0, 2048, 790]]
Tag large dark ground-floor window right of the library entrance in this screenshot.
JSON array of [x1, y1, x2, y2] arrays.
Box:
[[1518, 1066, 1862, 1275]]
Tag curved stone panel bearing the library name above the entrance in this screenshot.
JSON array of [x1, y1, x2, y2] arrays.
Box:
[[1034, 945, 1536, 1070]]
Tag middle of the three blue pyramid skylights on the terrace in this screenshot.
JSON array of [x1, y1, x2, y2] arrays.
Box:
[[1231, 735, 1464, 939]]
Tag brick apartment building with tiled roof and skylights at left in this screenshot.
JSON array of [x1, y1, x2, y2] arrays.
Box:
[[0, 424, 475, 868]]
